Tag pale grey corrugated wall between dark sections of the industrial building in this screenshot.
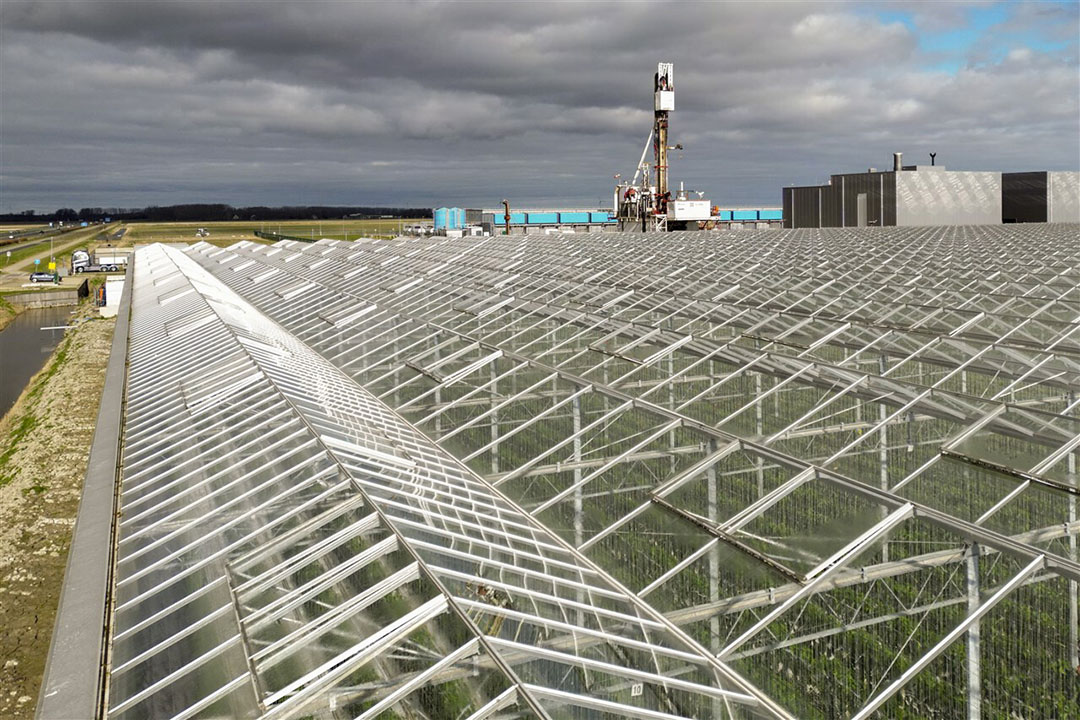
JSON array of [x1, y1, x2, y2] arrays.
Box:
[[895, 169, 1001, 226]]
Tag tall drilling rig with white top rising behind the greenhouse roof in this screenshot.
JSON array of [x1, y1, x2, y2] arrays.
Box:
[[613, 63, 711, 231]]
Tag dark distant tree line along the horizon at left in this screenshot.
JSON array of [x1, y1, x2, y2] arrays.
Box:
[[0, 203, 431, 222]]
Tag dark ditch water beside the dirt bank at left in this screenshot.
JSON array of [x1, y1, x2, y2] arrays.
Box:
[[0, 305, 75, 417]]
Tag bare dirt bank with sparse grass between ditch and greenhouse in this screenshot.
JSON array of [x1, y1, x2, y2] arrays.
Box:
[[0, 305, 116, 720]]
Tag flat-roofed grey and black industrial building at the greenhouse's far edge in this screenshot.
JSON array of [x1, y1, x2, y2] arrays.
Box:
[[783, 152, 1080, 228]]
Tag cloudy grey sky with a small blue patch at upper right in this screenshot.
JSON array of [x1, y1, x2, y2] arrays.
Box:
[[0, 0, 1080, 212]]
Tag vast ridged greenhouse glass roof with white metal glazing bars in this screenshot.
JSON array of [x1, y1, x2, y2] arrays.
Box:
[[71, 226, 1080, 719]]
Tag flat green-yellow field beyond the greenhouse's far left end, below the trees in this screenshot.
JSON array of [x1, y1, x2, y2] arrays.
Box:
[[123, 218, 430, 245]]
